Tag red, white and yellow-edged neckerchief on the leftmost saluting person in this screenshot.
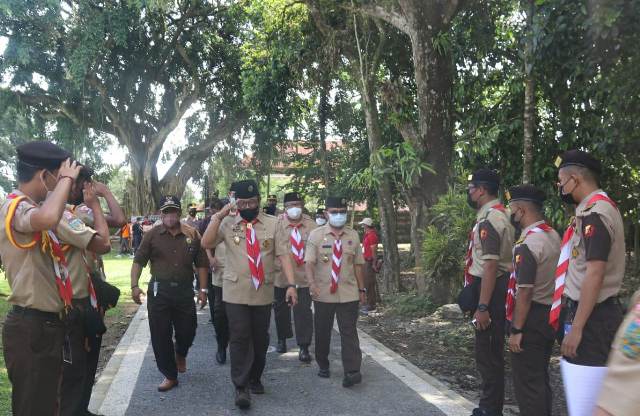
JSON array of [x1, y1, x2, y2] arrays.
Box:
[[5, 193, 73, 309]]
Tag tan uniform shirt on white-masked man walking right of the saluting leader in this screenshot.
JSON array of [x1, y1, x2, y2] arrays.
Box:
[[305, 225, 364, 303]]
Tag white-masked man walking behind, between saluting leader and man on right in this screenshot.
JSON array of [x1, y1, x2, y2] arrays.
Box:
[[273, 192, 317, 363]]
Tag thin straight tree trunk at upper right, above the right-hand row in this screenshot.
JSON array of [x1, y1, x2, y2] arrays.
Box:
[[522, 0, 536, 183]]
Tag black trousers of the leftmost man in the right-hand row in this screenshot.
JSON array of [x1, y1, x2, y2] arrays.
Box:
[[475, 274, 509, 414]]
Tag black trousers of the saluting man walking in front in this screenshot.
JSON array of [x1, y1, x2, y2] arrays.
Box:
[[225, 303, 271, 388]]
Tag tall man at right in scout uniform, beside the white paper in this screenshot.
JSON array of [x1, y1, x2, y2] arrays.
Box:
[[550, 150, 626, 367]]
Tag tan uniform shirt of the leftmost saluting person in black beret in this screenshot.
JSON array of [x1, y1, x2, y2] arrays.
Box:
[[0, 191, 63, 313]]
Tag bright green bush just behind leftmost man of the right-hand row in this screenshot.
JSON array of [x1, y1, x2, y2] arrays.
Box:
[[422, 187, 476, 301]]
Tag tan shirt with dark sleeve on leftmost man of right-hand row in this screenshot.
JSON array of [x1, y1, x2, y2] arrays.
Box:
[[469, 199, 515, 277]]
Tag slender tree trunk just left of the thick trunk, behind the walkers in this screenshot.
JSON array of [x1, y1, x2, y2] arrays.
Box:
[[361, 76, 401, 293]]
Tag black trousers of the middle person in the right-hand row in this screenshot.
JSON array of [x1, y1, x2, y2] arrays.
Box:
[[511, 303, 555, 416]]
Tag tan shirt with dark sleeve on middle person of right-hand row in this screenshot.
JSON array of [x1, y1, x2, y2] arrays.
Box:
[[513, 221, 560, 305]]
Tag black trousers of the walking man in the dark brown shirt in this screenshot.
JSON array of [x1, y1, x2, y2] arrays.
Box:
[[147, 281, 197, 380]]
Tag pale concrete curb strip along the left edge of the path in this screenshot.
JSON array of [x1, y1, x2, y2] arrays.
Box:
[[89, 303, 150, 416]]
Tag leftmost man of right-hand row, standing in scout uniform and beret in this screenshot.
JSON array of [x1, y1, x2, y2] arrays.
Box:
[[465, 169, 514, 416]]
